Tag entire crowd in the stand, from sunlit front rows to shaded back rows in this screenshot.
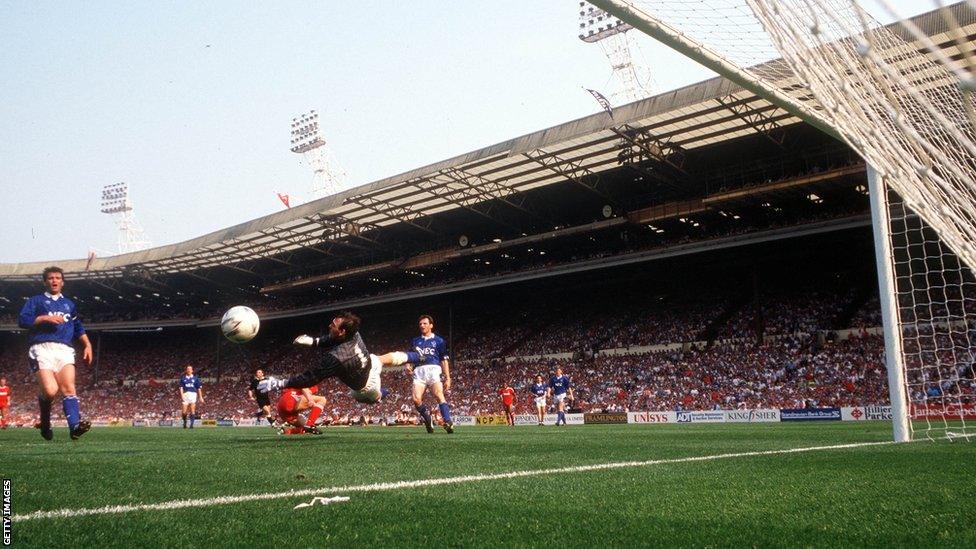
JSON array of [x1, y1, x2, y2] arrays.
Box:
[[0, 282, 944, 423]]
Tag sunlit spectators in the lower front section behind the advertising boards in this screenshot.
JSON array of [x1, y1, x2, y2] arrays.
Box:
[[0, 330, 908, 421]]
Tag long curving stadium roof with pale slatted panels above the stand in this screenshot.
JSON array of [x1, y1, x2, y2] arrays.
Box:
[[0, 5, 976, 281]]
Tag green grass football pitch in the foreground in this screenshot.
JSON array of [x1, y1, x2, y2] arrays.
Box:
[[0, 422, 976, 547]]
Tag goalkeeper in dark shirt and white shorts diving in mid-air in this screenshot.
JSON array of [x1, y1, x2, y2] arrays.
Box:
[[257, 312, 408, 404]]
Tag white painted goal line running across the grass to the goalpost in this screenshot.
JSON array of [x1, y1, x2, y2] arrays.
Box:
[[12, 441, 895, 522]]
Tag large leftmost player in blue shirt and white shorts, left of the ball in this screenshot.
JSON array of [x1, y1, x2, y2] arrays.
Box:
[[17, 267, 92, 440]]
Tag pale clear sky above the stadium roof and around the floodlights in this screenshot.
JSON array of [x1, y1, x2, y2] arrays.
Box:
[[0, 0, 930, 262]]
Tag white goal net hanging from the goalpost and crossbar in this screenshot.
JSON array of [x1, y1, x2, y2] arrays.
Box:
[[591, 0, 976, 440]]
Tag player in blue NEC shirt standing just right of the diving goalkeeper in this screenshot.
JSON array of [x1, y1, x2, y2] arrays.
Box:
[[407, 315, 454, 434]]
